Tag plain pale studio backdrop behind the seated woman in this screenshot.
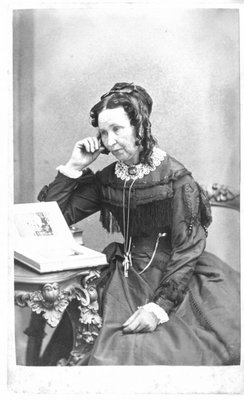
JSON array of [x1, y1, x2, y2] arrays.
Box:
[[13, 4, 240, 368]]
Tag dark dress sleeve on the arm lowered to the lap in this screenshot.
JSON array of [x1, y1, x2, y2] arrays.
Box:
[[153, 176, 209, 313]]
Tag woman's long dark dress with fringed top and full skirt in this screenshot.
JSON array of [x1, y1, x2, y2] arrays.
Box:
[[38, 150, 240, 365]]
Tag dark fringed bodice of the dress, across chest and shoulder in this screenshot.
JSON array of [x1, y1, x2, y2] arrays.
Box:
[[96, 155, 210, 236]]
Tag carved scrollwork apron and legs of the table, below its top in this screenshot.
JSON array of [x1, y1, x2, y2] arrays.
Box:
[[15, 270, 102, 365]]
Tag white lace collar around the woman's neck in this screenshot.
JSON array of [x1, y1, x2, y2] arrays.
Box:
[[115, 147, 166, 181]]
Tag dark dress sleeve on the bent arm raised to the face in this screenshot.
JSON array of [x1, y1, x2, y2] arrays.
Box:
[[37, 169, 100, 225]]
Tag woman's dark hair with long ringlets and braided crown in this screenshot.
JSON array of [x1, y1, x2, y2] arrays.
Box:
[[90, 82, 157, 164]]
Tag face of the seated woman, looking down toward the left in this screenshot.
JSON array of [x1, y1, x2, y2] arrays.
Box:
[[98, 107, 140, 165]]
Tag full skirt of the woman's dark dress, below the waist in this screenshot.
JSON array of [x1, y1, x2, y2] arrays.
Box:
[[41, 243, 240, 366]]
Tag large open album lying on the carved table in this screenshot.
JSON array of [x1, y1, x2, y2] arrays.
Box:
[[14, 201, 107, 272]]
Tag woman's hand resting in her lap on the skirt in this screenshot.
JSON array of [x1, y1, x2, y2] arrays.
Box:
[[122, 308, 158, 333]]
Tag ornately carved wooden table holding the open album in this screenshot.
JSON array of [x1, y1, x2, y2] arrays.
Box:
[[15, 261, 102, 366]]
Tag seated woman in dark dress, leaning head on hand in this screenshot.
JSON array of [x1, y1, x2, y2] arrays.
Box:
[[39, 83, 240, 365]]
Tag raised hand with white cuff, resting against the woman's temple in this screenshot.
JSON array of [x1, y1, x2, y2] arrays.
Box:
[[66, 136, 104, 171]]
